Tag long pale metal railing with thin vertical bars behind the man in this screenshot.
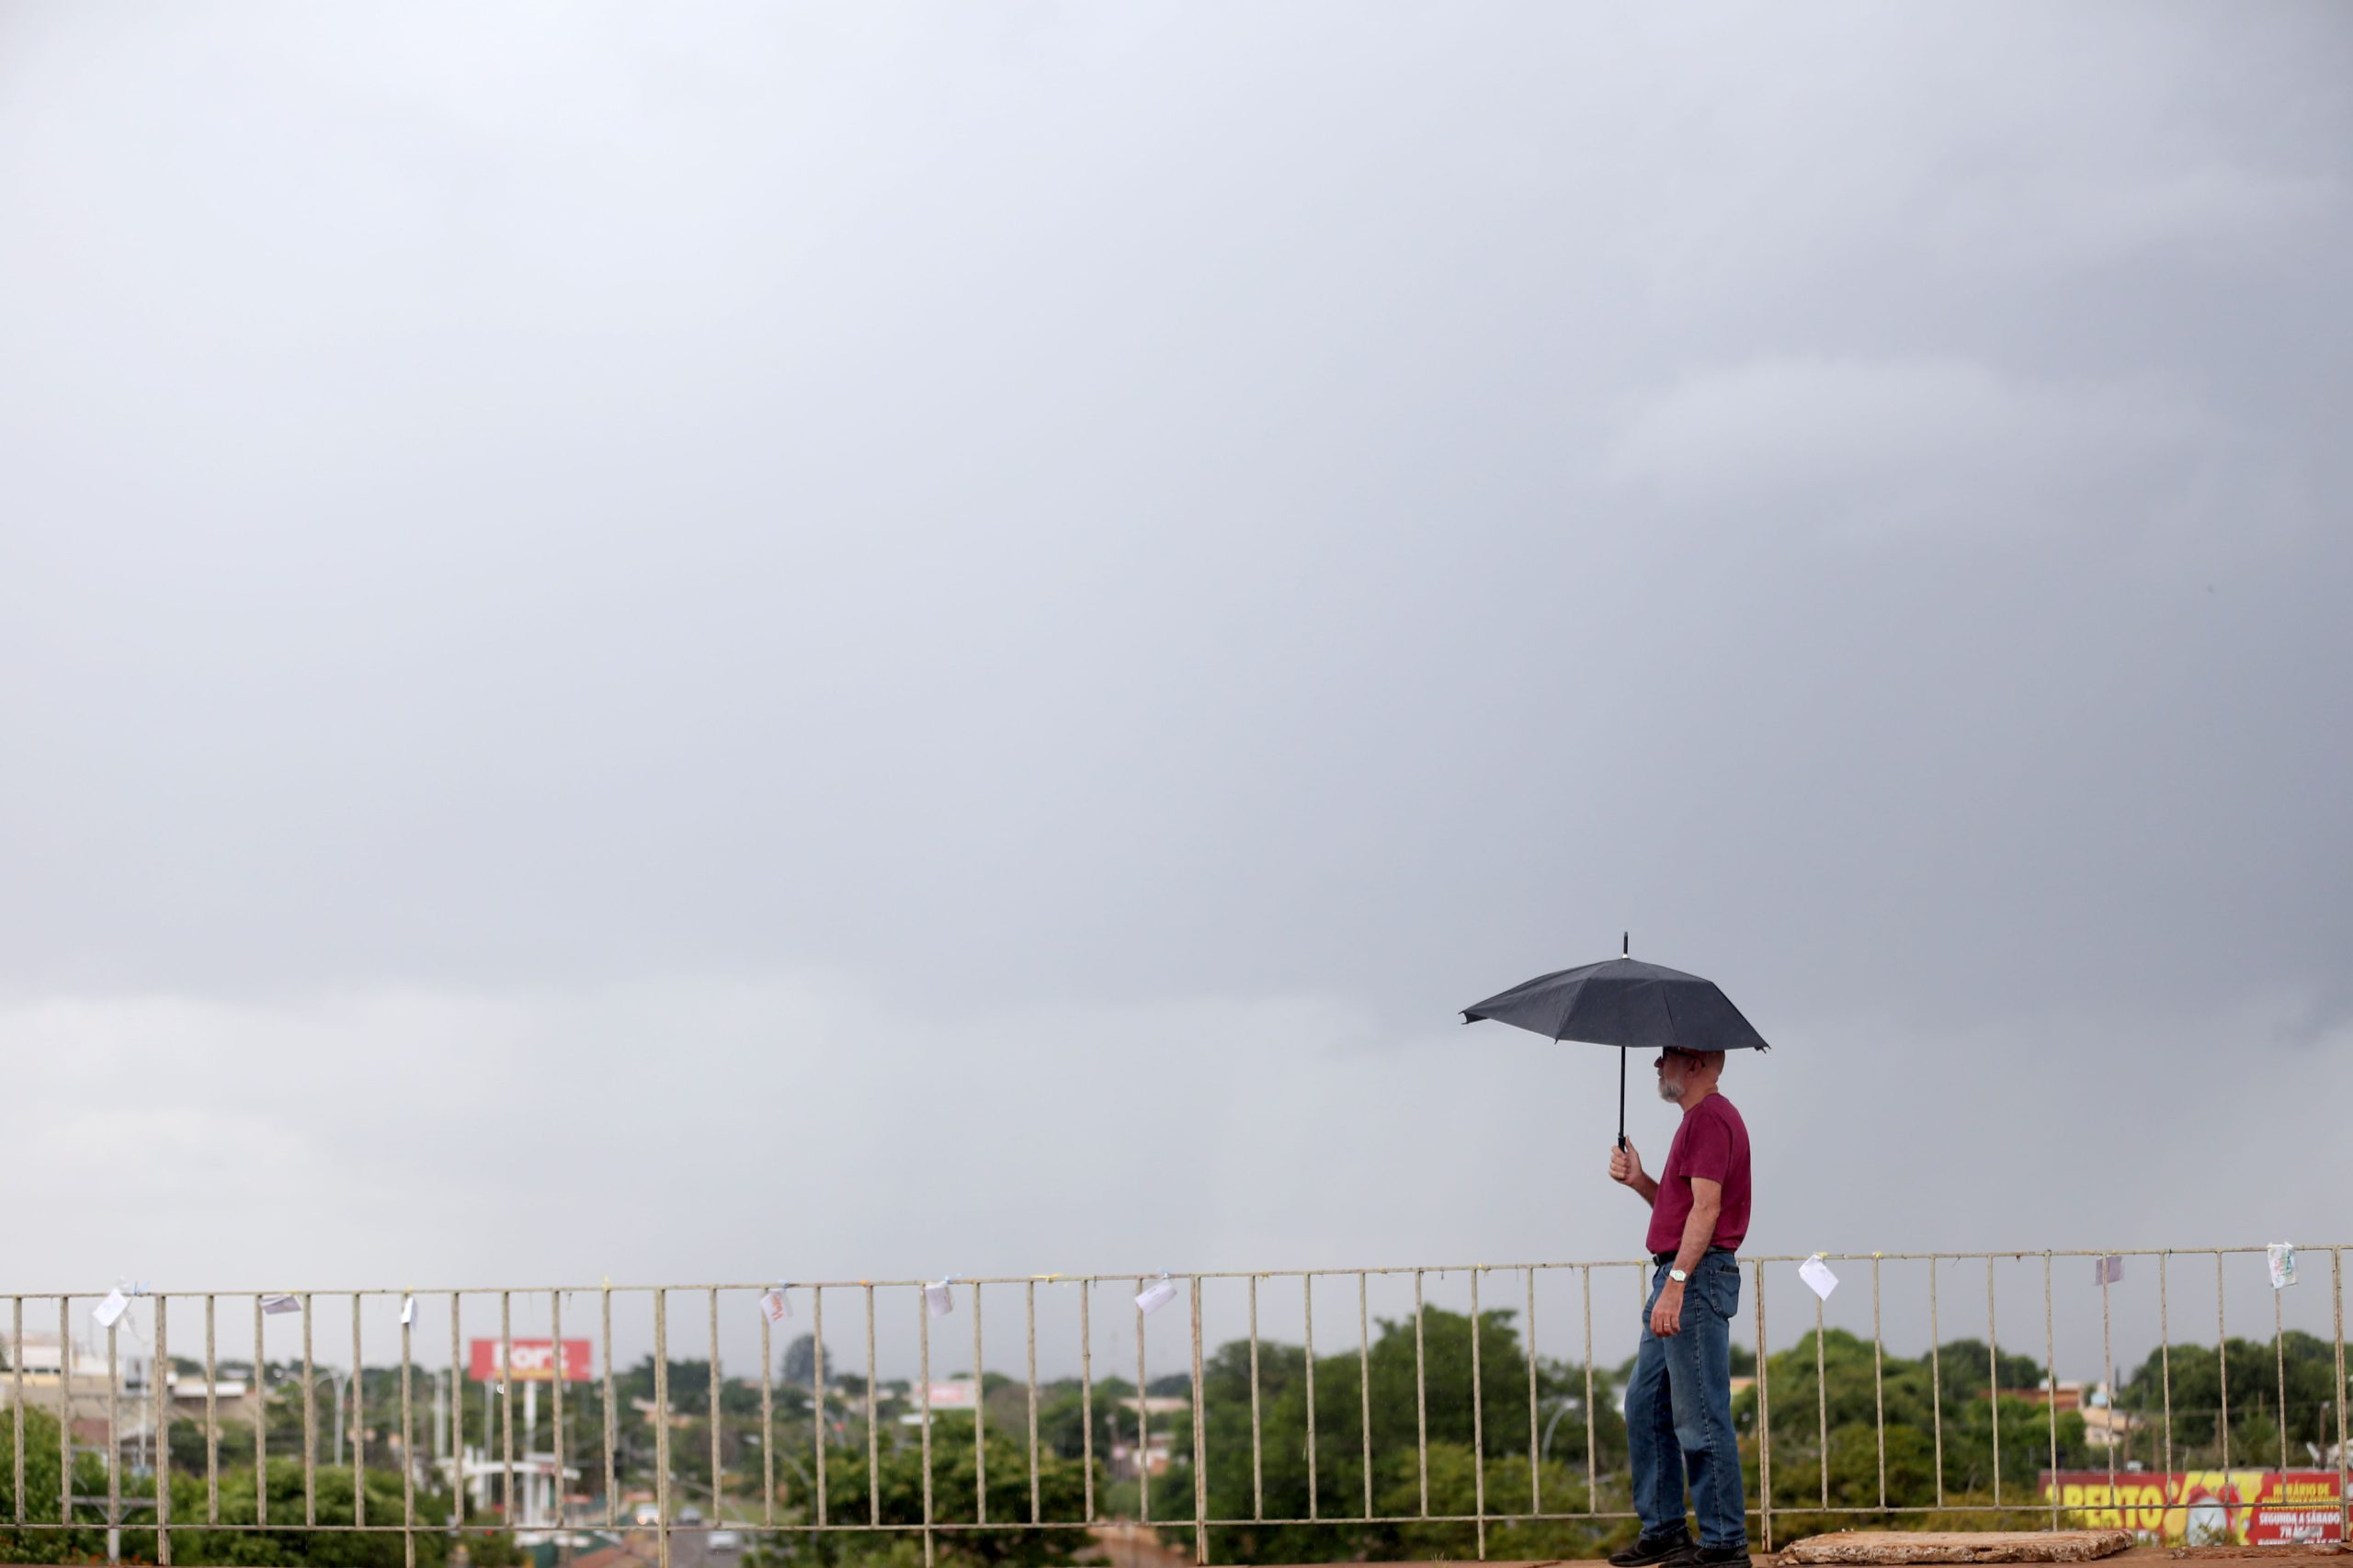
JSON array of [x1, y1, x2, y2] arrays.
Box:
[[0, 1245, 2353, 1565]]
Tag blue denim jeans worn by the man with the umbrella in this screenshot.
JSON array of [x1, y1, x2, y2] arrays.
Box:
[[1626, 1253, 1748, 1547]]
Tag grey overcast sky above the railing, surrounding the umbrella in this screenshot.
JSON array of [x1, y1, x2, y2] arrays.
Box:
[[0, 3, 2353, 1356]]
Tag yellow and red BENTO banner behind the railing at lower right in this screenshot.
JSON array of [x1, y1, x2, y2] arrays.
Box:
[[2042, 1469, 2344, 1547]]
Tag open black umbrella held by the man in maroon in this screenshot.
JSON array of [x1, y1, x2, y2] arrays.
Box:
[[1463, 937, 1772, 1149]]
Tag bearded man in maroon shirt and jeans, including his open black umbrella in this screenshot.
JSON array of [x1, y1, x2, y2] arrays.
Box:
[[1463, 953, 1765, 1568]]
